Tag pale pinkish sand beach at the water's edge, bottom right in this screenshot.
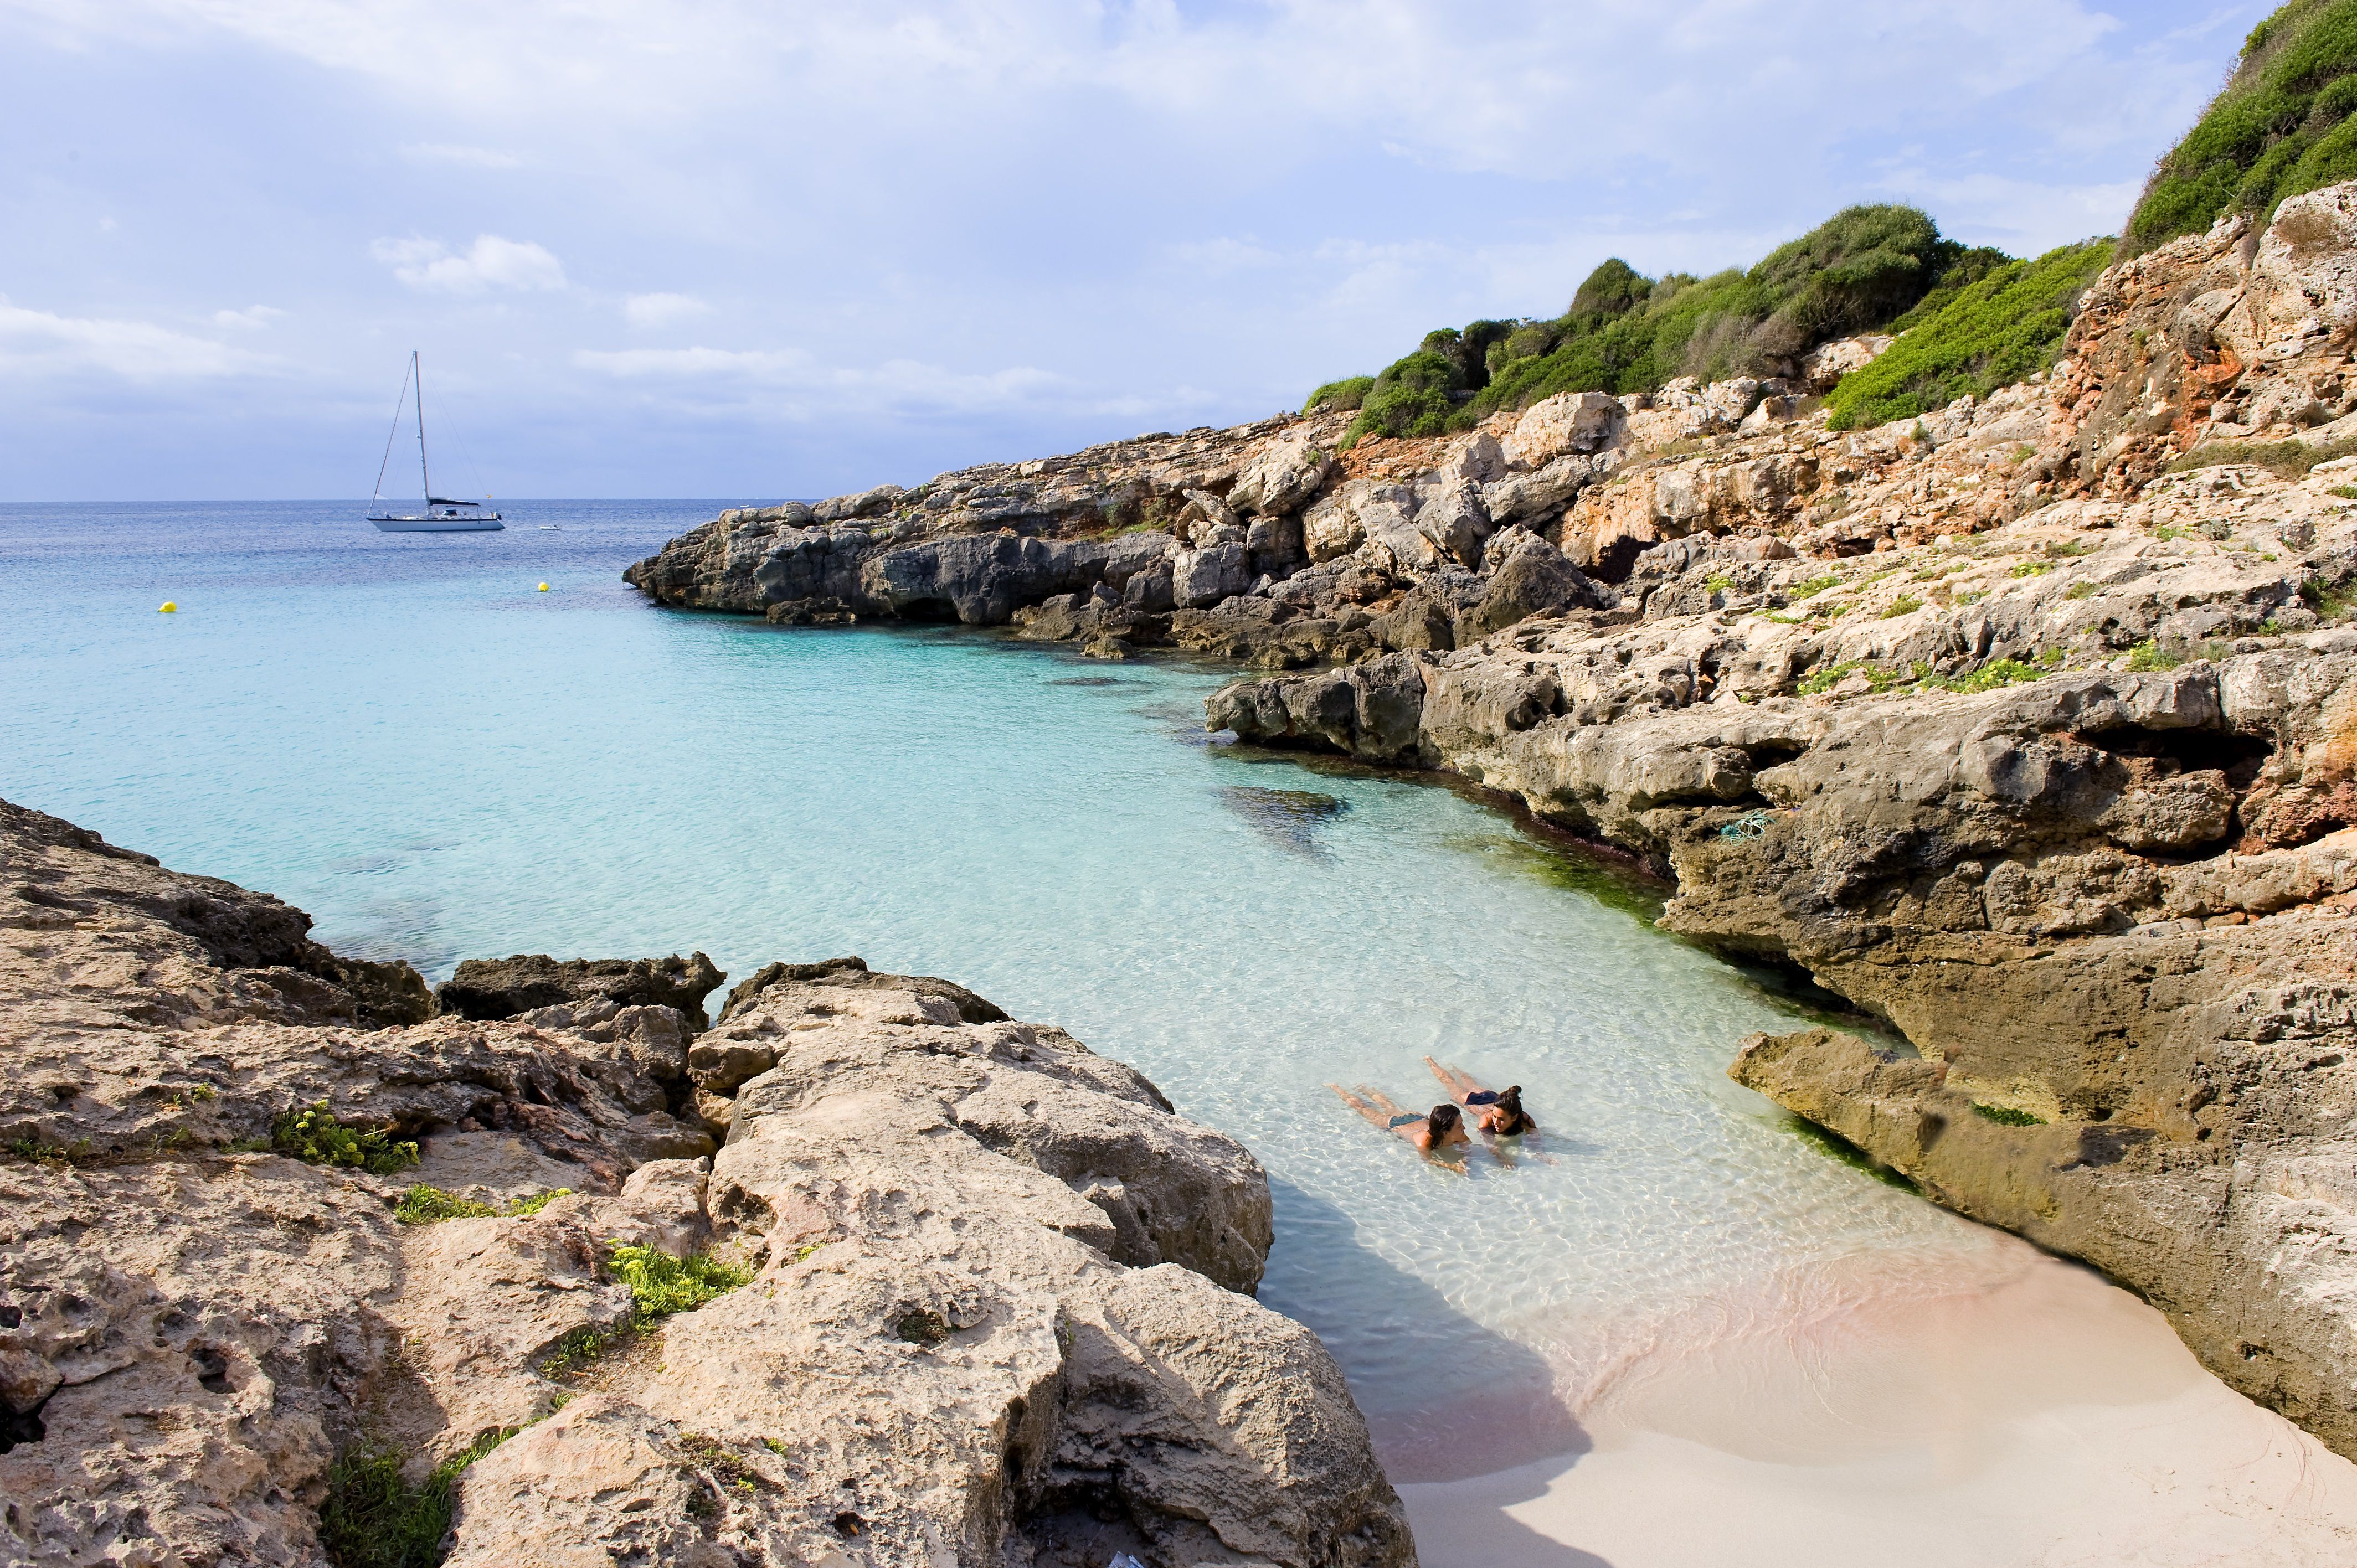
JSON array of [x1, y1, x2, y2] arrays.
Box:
[[1377, 1238, 2357, 1568]]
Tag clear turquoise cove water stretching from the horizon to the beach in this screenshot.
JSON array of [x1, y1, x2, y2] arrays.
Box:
[[0, 502, 1994, 1478]]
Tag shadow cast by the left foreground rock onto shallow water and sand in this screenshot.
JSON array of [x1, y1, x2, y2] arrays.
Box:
[[1261, 1174, 1610, 1568]]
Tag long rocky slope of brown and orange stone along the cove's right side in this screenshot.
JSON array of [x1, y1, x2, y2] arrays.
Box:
[[629, 184, 2357, 1455]]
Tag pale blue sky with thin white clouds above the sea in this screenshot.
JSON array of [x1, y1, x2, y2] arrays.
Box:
[[0, 0, 2272, 502]]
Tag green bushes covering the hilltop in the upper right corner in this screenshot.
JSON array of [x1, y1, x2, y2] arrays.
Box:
[[2121, 0, 2357, 255]]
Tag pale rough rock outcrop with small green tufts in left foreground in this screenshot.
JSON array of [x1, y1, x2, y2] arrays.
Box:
[[0, 804, 1414, 1568]]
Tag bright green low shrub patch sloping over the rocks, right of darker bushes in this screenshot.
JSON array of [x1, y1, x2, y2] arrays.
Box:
[[1824, 240, 2112, 429]]
